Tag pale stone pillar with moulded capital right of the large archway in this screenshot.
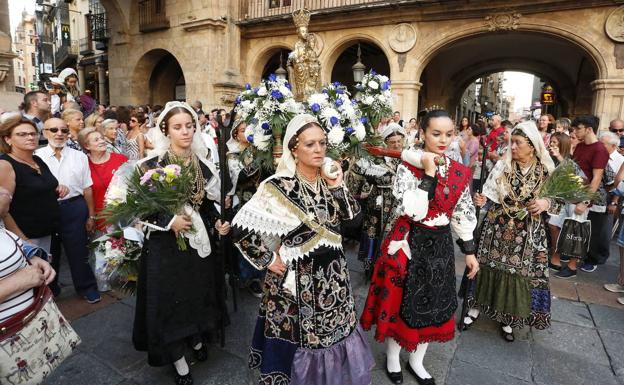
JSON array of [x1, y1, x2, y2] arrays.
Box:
[[590, 79, 624, 129]]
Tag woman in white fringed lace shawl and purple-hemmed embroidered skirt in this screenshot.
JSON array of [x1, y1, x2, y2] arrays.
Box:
[[232, 114, 374, 385]]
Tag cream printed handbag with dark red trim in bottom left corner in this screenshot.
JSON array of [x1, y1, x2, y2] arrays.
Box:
[[0, 250, 81, 385]]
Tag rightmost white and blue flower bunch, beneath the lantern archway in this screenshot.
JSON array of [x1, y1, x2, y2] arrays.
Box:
[[355, 70, 392, 135]]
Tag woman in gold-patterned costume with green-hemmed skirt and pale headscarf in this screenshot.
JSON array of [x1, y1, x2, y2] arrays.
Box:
[[463, 122, 561, 342]]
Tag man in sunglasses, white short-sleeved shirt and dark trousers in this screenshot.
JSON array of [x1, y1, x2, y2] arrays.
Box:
[[35, 118, 101, 303]]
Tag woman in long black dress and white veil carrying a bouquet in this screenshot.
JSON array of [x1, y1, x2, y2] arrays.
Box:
[[132, 102, 229, 385]]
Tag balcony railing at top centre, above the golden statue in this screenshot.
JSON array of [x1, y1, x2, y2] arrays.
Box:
[[239, 0, 409, 21]]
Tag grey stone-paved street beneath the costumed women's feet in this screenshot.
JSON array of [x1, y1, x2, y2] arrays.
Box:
[[45, 240, 624, 385]]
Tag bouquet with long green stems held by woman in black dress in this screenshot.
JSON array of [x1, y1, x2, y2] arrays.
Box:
[[102, 163, 195, 250]]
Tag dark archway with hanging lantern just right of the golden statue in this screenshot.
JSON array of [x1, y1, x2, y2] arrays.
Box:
[[331, 41, 390, 93]]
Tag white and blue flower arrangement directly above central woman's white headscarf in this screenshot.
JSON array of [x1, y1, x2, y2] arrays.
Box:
[[307, 82, 366, 159]]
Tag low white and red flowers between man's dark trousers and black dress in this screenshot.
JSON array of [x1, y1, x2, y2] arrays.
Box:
[[93, 227, 143, 294]]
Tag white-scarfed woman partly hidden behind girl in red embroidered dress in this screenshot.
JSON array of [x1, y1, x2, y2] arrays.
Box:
[[352, 122, 405, 277]]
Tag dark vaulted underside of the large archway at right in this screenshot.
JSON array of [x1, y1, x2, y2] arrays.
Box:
[[419, 31, 599, 121]]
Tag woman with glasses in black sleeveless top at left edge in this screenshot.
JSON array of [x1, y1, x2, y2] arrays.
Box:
[[0, 112, 68, 253]]
